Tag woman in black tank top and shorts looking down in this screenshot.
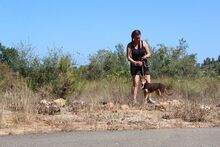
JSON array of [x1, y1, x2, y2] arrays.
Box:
[[127, 30, 154, 103]]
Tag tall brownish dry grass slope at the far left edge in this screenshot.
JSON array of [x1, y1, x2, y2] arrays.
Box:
[[0, 64, 39, 113]]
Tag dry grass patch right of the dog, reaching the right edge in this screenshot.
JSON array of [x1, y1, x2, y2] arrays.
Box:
[[156, 77, 220, 104]]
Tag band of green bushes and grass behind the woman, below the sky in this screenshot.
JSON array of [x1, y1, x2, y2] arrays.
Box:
[[0, 39, 220, 103]]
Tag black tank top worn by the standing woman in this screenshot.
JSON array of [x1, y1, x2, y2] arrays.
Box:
[[131, 40, 146, 61]]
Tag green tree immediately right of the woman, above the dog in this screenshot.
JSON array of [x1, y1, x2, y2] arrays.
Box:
[[150, 39, 198, 77]]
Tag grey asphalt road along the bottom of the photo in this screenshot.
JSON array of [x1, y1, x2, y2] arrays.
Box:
[[0, 128, 220, 147]]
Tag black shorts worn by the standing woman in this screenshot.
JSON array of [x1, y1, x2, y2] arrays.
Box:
[[130, 63, 150, 76]]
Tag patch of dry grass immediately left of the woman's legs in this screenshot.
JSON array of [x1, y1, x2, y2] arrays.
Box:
[[75, 79, 131, 104]]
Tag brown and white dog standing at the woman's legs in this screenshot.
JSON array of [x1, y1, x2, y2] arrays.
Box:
[[141, 77, 172, 98]]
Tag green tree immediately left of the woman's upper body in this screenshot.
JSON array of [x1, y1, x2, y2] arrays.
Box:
[[87, 44, 129, 79]]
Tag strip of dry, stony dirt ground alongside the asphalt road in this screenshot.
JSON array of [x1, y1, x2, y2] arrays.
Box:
[[0, 100, 220, 135]]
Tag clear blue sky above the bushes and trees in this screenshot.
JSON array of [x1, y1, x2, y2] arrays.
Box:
[[0, 0, 220, 64]]
